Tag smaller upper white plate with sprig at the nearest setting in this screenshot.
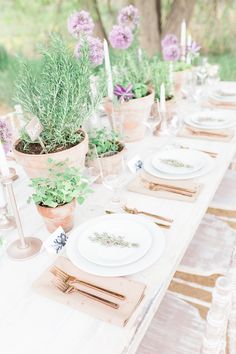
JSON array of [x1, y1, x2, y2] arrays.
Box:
[[77, 217, 152, 267]]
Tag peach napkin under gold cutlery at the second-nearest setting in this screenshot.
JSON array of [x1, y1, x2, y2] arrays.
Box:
[[127, 171, 202, 202]]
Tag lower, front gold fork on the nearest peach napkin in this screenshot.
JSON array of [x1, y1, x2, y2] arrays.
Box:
[[54, 277, 119, 309]]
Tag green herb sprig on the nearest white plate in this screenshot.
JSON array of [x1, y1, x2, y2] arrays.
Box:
[[89, 232, 139, 248]]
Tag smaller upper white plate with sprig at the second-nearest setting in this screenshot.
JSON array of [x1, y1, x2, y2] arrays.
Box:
[[152, 149, 206, 175]]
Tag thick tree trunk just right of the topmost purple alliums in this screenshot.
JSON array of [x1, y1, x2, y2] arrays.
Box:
[[132, 0, 160, 55]]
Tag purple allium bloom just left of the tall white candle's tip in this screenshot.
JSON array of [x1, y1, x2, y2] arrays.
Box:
[[75, 37, 104, 66]]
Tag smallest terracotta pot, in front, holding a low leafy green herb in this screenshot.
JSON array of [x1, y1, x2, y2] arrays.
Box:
[[37, 199, 76, 233]]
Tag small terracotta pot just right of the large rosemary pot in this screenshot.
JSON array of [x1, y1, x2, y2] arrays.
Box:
[[88, 144, 125, 183]]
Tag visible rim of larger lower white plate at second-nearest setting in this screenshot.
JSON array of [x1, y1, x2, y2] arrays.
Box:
[[144, 151, 215, 180]]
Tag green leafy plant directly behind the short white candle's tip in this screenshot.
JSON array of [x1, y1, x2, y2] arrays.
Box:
[[150, 56, 173, 100]]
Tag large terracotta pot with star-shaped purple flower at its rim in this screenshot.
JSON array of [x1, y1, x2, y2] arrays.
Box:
[[104, 89, 154, 142]]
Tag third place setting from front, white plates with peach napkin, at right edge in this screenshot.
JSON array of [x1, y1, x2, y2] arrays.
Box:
[[178, 109, 236, 142]]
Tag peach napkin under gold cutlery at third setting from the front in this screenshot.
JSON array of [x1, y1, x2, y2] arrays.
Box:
[[177, 125, 234, 142]]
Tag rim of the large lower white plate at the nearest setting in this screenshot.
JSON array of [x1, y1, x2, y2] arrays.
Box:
[[66, 213, 166, 277]]
